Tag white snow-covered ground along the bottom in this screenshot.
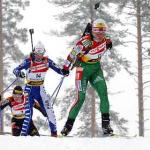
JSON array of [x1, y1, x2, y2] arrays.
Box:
[[0, 135, 150, 150]]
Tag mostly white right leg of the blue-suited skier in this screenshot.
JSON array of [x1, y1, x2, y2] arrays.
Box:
[[38, 86, 57, 136]]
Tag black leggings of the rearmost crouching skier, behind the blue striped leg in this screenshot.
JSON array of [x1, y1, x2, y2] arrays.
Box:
[[11, 117, 40, 136]]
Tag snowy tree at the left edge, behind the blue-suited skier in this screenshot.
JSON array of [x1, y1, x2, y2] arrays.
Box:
[[0, 0, 29, 131]]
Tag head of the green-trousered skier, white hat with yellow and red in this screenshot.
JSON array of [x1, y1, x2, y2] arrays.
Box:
[[92, 19, 107, 40]]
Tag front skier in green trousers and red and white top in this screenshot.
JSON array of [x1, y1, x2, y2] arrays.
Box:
[[61, 19, 113, 136]]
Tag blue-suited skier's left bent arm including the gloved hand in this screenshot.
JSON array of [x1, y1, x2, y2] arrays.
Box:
[[13, 59, 30, 78]]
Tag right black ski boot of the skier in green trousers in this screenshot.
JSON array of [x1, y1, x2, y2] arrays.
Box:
[[102, 113, 113, 136]]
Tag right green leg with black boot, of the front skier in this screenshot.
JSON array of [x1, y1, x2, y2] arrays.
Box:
[[90, 67, 113, 134]]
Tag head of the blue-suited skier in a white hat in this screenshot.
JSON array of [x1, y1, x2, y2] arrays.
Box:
[[33, 41, 45, 61]]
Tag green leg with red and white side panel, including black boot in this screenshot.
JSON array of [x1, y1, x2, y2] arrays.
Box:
[[61, 67, 88, 136]]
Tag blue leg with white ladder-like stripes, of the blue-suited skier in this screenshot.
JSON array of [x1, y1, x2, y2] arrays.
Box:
[[21, 86, 34, 136]]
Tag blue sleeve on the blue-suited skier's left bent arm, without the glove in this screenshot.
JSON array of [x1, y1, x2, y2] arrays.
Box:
[[13, 59, 30, 76]]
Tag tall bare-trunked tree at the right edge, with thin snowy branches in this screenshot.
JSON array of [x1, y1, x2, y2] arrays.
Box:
[[108, 0, 150, 136]]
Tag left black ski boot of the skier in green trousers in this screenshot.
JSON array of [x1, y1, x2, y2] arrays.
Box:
[[61, 118, 75, 136]]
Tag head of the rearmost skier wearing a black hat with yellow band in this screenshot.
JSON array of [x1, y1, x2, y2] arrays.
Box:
[[13, 86, 23, 101]]
